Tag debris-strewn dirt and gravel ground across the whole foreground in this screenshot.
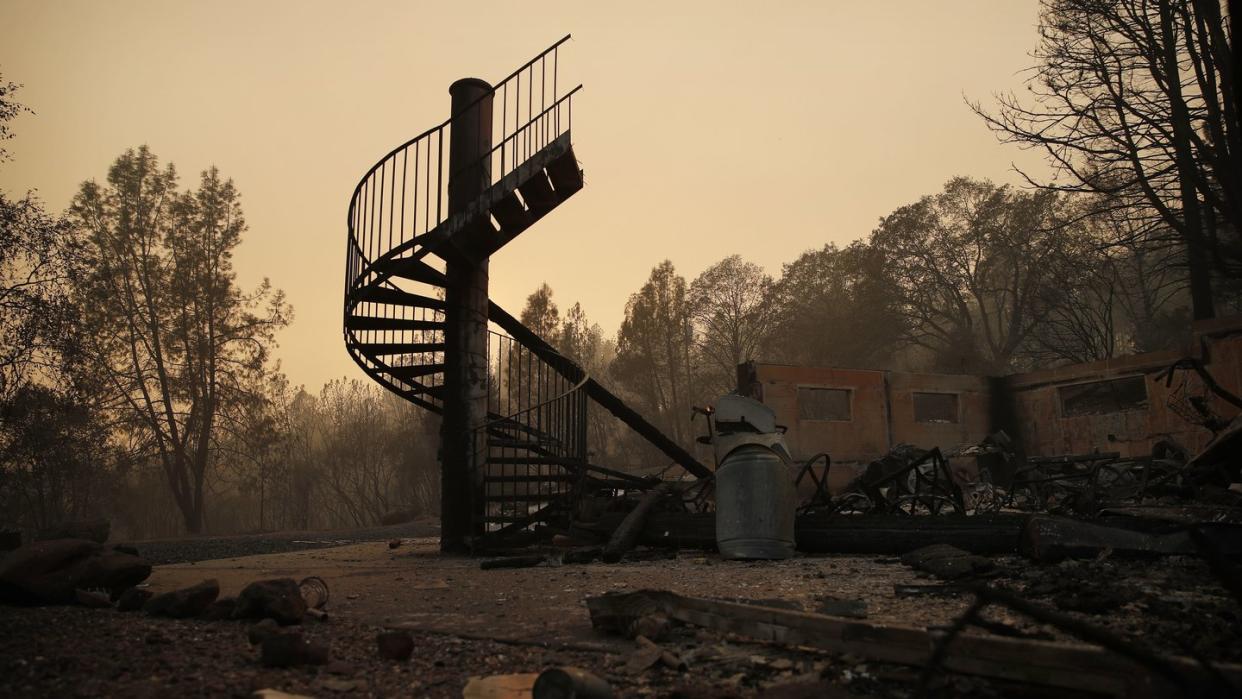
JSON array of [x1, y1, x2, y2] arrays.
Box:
[[0, 538, 1242, 698]]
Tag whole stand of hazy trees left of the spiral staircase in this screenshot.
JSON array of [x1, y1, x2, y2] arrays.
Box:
[[0, 75, 438, 538]]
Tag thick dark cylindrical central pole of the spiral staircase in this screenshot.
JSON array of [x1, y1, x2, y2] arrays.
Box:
[[440, 78, 492, 552]]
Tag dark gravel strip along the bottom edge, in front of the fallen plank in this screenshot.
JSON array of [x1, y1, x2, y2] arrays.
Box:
[[0, 598, 1028, 699]]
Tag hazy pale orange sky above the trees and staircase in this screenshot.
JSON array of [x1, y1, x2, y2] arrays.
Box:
[[0, 0, 1038, 390]]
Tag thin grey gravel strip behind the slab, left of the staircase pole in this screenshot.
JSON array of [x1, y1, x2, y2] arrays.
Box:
[[114, 520, 440, 565]]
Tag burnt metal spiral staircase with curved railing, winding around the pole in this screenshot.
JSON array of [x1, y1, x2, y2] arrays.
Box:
[[344, 36, 710, 538]]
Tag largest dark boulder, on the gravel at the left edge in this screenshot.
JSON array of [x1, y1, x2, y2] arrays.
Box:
[[0, 539, 152, 605]]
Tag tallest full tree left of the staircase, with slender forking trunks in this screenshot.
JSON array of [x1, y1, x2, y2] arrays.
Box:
[[71, 147, 289, 533]]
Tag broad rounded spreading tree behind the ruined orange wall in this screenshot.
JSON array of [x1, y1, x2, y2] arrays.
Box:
[[871, 178, 1076, 372]]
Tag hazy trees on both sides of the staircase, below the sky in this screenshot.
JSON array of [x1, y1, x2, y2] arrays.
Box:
[[0, 0, 1242, 536]]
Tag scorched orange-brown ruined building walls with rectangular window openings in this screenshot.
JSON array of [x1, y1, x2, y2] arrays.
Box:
[[738, 315, 1242, 487]]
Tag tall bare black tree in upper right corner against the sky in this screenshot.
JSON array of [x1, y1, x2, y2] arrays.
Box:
[[971, 0, 1242, 318]]
